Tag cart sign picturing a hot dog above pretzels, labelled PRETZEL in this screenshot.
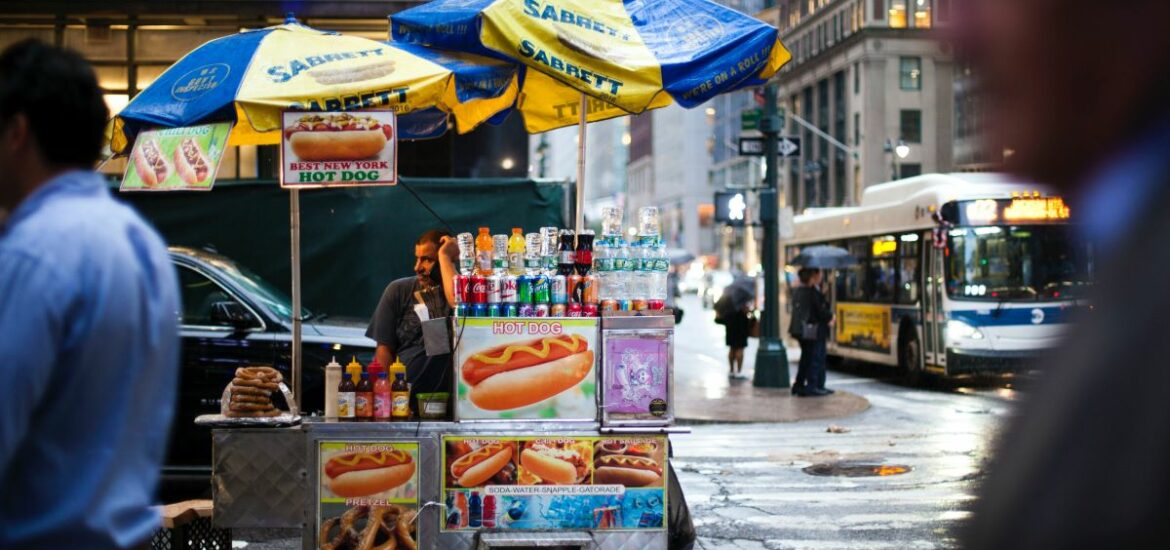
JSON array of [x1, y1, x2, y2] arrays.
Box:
[[317, 440, 419, 548]]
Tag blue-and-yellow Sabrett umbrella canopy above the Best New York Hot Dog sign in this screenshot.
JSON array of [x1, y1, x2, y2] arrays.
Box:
[[106, 20, 517, 154]]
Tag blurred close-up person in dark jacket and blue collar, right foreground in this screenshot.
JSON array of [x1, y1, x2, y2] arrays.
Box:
[[952, 0, 1170, 549]]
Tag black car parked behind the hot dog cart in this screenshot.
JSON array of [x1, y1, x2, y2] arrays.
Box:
[[163, 247, 374, 496]]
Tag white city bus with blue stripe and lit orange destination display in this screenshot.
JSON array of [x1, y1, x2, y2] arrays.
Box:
[[782, 173, 1093, 380]]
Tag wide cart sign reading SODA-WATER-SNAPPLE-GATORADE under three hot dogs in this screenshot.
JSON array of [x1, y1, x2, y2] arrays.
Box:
[[441, 435, 668, 531]]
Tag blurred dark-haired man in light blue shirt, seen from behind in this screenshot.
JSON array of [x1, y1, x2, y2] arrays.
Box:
[[0, 41, 179, 549]]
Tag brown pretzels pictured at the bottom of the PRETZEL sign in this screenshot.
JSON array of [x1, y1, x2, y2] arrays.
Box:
[[318, 504, 418, 550]]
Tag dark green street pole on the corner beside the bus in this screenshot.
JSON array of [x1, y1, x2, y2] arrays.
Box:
[[751, 84, 790, 387]]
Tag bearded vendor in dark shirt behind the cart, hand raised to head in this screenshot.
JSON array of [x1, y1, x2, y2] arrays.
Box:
[[366, 229, 455, 415]]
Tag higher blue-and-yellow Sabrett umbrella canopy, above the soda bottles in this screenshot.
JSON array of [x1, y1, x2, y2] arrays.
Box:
[[391, 0, 791, 132]]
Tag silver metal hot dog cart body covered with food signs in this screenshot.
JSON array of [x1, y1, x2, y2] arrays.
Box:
[[212, 310, 684, 549]]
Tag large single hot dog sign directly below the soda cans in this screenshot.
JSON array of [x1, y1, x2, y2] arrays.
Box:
[[455, 317, 599, 420]]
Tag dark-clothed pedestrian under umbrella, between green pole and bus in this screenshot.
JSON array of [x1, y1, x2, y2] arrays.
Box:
[[789, 268, 833, 397]]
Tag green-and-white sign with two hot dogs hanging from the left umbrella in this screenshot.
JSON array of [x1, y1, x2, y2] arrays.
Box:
[[122, 122, 232, 192]]
